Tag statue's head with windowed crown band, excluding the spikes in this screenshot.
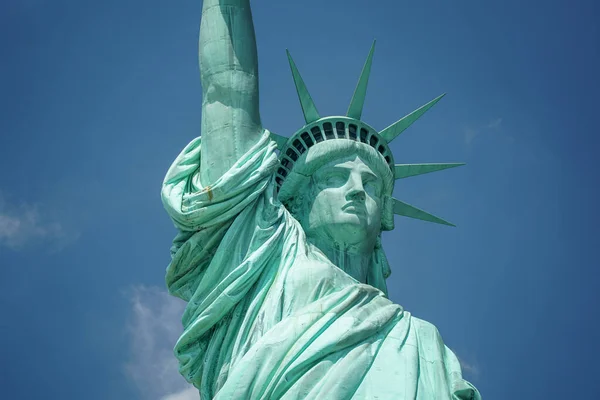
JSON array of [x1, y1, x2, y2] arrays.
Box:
[[276, 117, 394, 252]]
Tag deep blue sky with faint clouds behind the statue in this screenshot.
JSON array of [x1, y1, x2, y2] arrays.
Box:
[[0, 0, 600, 400]]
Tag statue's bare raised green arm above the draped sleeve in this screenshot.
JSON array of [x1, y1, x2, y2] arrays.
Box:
[[199, 0, 262, 185]]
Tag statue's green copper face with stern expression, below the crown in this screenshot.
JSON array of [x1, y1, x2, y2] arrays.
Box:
[[304, 156, 383, 251]]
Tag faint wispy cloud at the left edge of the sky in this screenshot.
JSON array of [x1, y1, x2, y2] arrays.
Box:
[[0, 193, 79, 251]]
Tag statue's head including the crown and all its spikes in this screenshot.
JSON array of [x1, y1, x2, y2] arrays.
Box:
[[272, 45, 463, 286]]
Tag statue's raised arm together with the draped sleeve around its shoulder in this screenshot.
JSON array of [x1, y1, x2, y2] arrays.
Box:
[[161, 0, 277, 301]]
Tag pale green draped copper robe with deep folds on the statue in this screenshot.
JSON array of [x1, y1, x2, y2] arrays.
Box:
[[162, 131, 480, 400]]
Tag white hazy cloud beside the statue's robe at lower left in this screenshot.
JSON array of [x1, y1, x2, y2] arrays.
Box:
[[125, 285, 200, 400]]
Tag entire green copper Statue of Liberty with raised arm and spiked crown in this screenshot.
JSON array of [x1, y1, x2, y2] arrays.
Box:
[[162, 0, 480, 400]]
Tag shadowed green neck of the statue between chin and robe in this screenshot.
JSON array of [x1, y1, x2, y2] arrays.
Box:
[[308, 237, 373, 283]]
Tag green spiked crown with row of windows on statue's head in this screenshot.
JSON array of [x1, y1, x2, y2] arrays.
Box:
[[271, 42, 464, 229]]
